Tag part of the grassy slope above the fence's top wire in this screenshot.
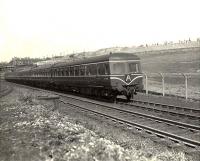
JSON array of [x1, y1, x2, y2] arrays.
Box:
[[138, 48, 200, 73]]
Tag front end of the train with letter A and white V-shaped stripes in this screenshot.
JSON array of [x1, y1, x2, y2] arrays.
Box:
[[109, 54, 143, 101]]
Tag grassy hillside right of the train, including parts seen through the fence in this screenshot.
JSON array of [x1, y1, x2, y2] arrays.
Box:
[[137, 48, 200, 99]]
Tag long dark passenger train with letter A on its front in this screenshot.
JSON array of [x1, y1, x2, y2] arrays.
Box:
[[5, 52, 143, 101]]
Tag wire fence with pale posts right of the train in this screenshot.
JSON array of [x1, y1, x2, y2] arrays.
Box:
[[143, 73, 200, 100]]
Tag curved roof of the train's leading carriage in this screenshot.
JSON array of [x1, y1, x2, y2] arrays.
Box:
[[52, 52, 140, 68]]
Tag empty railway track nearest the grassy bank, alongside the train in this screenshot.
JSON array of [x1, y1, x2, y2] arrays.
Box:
[[6, 82, 200, 149]]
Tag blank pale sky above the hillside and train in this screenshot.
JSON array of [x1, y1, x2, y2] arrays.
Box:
[[0, 0, 200, 62]]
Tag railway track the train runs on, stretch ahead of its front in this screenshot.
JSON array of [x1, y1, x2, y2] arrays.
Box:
[[115, 100, 200, 125]]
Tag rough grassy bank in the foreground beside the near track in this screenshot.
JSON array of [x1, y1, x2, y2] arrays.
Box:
[[0, 88, 199, 161]]
